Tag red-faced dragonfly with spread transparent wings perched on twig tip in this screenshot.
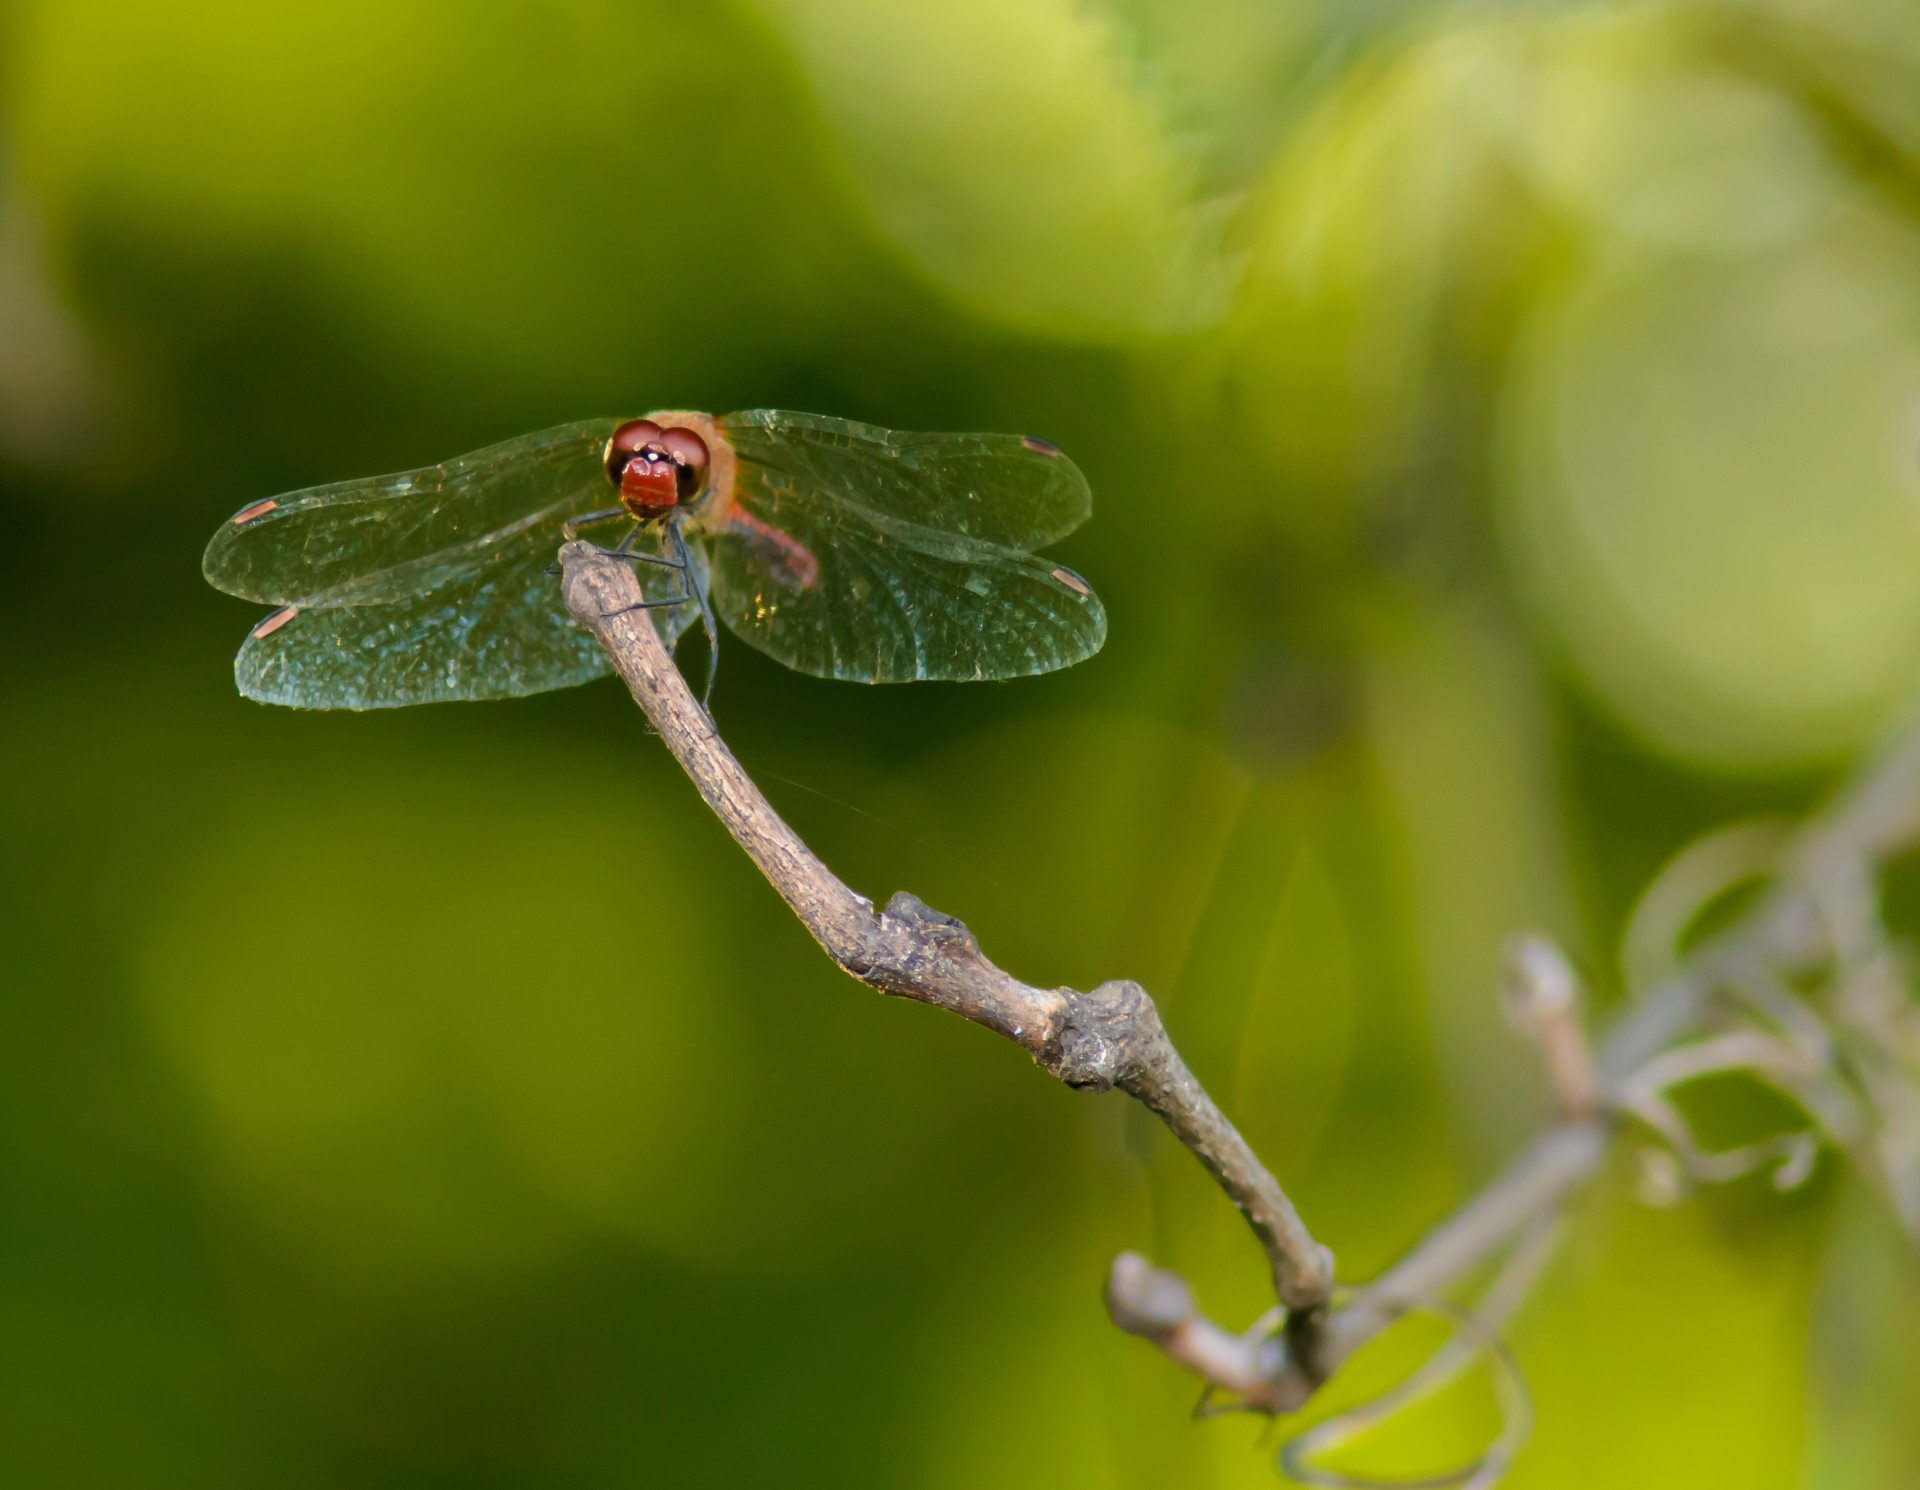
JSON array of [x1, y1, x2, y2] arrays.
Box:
[[204, 409, 1106, 709]]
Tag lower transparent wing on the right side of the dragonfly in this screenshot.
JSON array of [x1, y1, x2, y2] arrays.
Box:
[[708, 463, 1106, 684]]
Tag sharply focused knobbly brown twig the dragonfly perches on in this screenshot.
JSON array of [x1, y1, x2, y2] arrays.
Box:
[[561, 543, 1332, 1336]]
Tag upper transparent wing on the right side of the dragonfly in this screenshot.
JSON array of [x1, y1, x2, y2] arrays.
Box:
[[718, 409, 1092, 549]]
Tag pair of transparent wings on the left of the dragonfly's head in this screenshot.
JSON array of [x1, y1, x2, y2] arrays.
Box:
[[204, 421, 693, 709]]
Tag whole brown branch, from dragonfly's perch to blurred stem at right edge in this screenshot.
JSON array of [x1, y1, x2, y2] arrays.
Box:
[[561, 543, 1920, 1413]]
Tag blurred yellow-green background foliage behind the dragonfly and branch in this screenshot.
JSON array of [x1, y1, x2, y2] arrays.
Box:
[[0, 0, 1920, 1490]]
